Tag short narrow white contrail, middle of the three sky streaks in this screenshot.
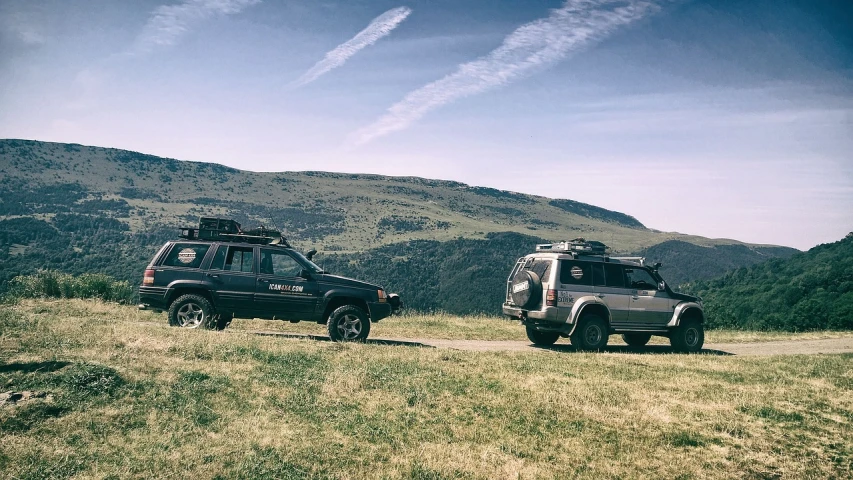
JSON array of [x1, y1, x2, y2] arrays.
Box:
[[290, 7, 412, 88]]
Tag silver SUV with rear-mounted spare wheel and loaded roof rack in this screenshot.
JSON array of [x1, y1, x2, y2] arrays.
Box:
[[503, 238, 705, 352]]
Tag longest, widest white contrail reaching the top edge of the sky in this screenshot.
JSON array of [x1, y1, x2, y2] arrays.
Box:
[[350, 0, 658, 145]]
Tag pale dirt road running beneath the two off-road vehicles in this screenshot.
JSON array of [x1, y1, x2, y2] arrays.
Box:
[[253, 332, 853, 355]]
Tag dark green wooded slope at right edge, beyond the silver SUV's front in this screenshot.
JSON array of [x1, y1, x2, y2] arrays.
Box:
[[689, 234, 853, 331]]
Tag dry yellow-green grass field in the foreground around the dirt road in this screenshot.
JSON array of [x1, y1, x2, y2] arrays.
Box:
[[0, 300, 853, 479]]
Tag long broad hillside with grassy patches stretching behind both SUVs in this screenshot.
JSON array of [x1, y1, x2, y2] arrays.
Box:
[[0, 140, 796, 313]]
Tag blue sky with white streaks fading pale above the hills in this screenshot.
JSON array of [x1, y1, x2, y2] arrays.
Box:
[[0, 0, 853, 249]]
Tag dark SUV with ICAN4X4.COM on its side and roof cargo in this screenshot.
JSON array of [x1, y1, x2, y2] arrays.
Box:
[[139, 219, 401, 341]]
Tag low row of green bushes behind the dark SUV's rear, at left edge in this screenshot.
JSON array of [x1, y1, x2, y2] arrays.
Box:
[[6, 270, 134, 303]]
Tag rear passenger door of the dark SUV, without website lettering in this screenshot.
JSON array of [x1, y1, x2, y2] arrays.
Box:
[[206, 244, 256, 316]]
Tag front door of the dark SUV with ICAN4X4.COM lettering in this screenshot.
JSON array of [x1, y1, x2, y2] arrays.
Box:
[[255, 248, 319, 319]]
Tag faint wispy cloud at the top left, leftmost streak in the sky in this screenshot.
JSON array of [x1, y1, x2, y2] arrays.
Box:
[[128, 0, 261, 54]]
